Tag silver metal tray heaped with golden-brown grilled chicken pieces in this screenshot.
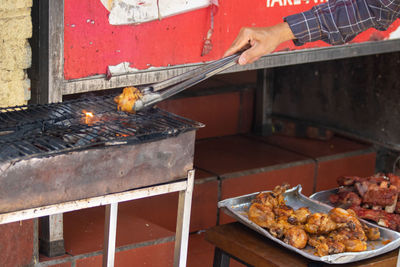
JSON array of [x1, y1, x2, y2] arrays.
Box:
[[218, 184, 400, 264]]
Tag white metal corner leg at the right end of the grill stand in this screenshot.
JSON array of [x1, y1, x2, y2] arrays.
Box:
[[174, 170, 194, 267]]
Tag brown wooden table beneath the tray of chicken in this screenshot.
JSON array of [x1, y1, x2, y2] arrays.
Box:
[[205, 222, 398, 267]]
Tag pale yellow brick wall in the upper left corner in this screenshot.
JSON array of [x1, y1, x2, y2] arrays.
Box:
[[0, 0, 32, 107]]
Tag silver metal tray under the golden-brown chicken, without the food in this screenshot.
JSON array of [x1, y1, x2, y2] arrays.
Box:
[[218, 185, 400, 264]]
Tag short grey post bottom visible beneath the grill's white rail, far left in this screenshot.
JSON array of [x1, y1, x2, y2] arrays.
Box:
[[39, 216, 65, 257]]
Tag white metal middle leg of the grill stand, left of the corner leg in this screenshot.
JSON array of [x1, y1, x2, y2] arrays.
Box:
[[103, 202, 118, 267]]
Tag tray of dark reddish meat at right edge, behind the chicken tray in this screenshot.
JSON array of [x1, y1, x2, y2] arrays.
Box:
[[310, 173, 400, 231]]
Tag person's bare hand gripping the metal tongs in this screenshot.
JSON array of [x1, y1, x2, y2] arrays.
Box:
[[224, 22, 295, 65]]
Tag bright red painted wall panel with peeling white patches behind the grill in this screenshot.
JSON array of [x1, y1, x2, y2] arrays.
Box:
[[64, 0, 400, 80]]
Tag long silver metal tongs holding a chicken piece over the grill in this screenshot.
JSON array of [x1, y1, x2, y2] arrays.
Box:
[[132, 53, 240, 111]]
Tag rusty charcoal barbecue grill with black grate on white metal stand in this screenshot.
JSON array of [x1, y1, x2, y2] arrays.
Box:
[[0, 95, 203, 266]]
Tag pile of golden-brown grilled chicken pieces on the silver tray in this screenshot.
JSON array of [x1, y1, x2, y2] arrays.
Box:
[[248, 184, 374, 257]]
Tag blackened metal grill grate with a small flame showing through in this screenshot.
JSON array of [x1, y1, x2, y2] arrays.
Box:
[[0, 96, 203, 162]]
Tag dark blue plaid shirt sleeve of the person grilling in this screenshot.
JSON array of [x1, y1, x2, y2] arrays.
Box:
[[284, 0, 400, 45]]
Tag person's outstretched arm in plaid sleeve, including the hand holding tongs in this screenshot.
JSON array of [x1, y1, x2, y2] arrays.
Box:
[[224, 0, 400, 65]]
